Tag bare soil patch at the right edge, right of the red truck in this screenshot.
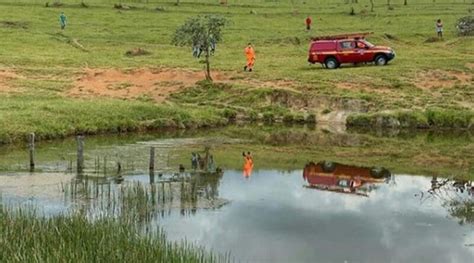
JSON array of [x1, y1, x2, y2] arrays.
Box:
[[414, 70, 474, 89]]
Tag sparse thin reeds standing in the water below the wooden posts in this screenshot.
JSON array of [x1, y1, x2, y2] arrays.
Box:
[[62, 171, 228, 224]]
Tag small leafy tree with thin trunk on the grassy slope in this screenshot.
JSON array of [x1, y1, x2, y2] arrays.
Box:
[[172, 15, 228, 81]]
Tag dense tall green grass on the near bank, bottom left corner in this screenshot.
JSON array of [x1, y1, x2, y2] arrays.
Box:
[[0, 204, 229, 263]]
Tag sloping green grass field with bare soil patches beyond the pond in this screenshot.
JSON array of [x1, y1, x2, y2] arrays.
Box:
[[0, 0, 474, 143]]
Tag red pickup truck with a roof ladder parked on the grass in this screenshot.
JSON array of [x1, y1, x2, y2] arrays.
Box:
[[308, 33, 395, 69]]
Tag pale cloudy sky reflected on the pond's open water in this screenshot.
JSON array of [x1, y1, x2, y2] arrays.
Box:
[[160, 170, 474, 263]]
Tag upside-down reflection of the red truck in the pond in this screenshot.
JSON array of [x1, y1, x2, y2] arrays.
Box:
[[303, 161, 390, 196]]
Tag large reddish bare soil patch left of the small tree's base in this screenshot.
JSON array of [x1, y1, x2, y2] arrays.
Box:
[[67, 68, 231, 102]]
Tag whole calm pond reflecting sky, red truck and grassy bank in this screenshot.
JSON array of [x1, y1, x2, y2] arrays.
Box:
[[0, 127, 474, 262]]
